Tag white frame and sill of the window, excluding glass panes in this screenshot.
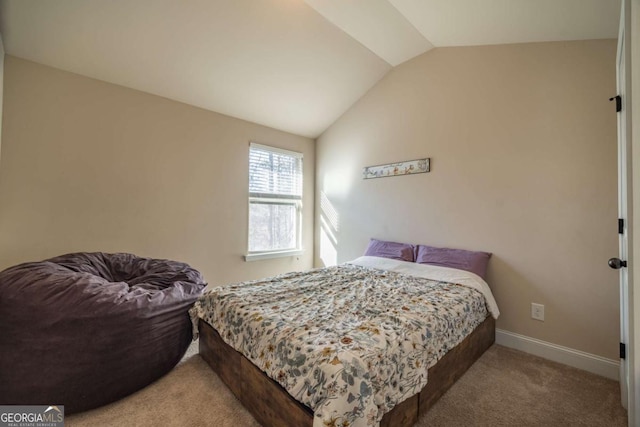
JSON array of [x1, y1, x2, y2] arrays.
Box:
[[244, 142, 304, 261]]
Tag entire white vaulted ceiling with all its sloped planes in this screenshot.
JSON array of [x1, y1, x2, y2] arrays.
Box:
[[0, 0, 620, 137]]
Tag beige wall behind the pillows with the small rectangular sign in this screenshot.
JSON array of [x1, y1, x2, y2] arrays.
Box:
[[316, 40, 619, 359]]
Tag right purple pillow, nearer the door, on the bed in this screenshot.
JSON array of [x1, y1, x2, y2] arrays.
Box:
[[416, 245, 491, 279]]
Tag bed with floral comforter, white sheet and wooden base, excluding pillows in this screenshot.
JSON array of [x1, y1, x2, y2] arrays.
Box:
[[191, 256, 499, 427]]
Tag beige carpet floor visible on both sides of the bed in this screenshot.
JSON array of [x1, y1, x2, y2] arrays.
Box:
[[65, 345, 627, 427]]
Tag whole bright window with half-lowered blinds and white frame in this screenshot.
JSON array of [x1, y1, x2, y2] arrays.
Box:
[[246, 143, 302, 260]]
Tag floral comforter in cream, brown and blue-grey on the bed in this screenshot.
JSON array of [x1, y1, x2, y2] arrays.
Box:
[[191, 258, 492, 427]]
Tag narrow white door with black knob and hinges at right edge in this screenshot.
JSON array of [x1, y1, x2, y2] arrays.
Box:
[[609, 0, 633, 410]]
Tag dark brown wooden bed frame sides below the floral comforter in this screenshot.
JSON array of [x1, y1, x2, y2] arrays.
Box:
[[199, 315, 496, 427]]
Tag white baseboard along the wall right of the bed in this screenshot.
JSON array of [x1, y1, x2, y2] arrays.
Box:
[[496, 329, 620, 381]]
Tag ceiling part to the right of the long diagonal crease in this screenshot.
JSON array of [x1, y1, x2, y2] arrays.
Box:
[[305, 0, 620, 61]]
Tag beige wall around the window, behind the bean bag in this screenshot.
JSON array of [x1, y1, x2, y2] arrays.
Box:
[[0, 56, 314, 284]]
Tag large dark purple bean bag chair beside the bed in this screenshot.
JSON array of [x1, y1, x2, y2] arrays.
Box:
[[0, 252, 206, 414]]
